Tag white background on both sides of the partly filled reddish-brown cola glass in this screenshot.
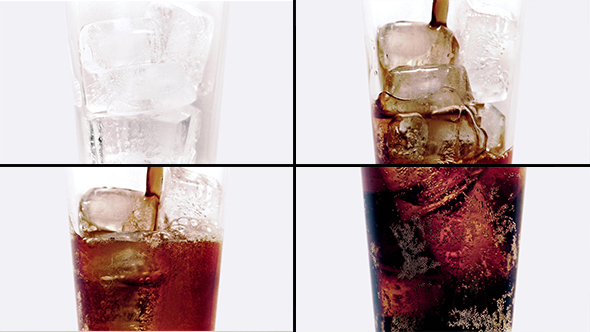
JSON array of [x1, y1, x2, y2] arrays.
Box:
[[0, 167, 293, 331]]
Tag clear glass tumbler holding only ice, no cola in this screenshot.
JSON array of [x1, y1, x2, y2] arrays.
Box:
[[67, 1, 226, 164]]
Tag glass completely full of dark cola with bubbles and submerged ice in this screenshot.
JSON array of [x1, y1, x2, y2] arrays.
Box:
[[362, 166, 526, 332]]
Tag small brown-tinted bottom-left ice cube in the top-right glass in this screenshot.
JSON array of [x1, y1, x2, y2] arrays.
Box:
[[387, 113, 428, 162]]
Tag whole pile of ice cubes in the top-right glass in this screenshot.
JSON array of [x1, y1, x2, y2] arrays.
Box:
[[374, 0, 516, 162]]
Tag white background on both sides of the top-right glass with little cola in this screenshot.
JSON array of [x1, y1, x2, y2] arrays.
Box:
[[296, 0, 590, 164]]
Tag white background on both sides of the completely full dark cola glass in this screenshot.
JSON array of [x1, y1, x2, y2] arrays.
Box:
[[295, 167, 590, 332]]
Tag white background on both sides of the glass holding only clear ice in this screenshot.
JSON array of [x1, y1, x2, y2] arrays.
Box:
[[0, 1, 293, 164]]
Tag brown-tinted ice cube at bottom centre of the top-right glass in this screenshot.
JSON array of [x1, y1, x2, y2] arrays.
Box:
[[425, 108, 486, 164]]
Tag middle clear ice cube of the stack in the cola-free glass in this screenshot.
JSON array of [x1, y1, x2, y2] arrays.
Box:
[[86, 63, 197, 114]]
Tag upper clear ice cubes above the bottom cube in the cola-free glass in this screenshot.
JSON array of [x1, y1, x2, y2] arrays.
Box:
[[79, 2, 213, 114]]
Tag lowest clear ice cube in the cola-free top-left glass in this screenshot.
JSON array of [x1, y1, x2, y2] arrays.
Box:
[[87, 105, 202, 164]]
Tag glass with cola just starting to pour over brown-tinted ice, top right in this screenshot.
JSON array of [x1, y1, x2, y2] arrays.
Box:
[[363, 0, 523, 164]]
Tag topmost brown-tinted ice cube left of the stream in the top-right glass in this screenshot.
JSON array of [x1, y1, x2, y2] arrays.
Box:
[[377, 22, 459, 73]]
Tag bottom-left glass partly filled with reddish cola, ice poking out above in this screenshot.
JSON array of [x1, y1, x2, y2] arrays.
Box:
[[69, 167, 225, 331]]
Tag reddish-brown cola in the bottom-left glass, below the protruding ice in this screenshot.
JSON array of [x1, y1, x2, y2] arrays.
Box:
[[72, 231, 221, 331]]
